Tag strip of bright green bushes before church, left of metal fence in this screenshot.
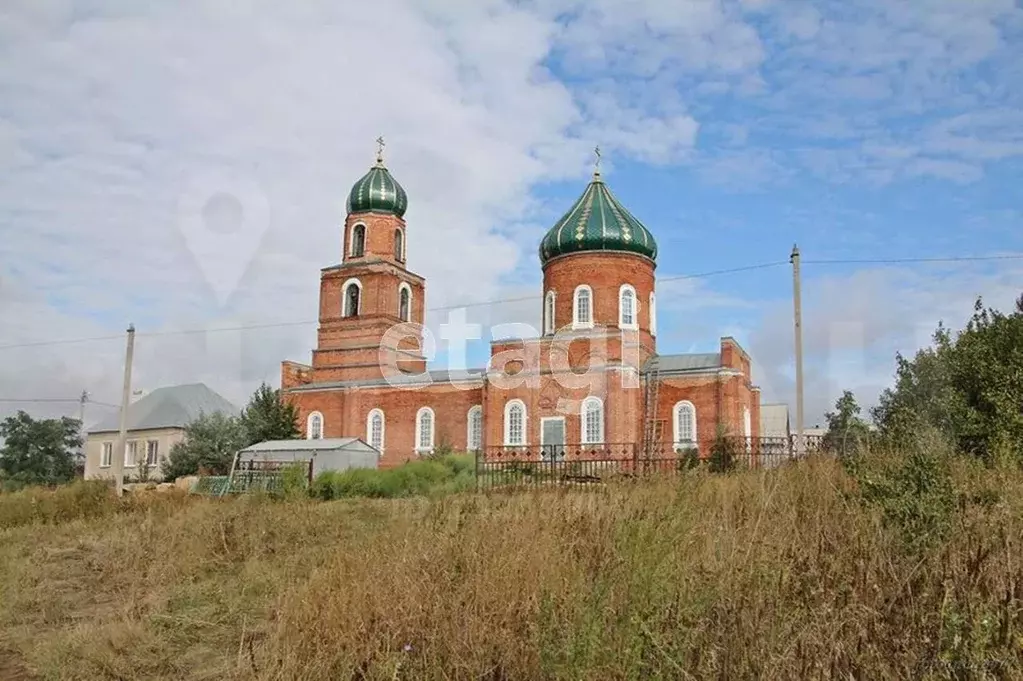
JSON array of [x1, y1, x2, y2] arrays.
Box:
[[310, 454, 476, 500]]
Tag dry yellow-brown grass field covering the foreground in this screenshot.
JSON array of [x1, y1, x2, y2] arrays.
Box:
[[0, 447, 1023, 681]]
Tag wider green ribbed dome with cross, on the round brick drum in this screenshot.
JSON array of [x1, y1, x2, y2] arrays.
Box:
[[540, 172, 657, 265]]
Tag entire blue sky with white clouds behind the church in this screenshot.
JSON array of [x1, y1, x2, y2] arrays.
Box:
[[0, 0, 1023, 421]]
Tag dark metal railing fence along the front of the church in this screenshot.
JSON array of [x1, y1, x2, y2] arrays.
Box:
[[476, 436, 822, 489]]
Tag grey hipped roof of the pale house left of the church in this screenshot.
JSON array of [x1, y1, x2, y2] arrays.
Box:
[[89, 383, 241, 433]]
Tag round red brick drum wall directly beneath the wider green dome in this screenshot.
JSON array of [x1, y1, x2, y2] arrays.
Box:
[[538, 252, 655, 361]]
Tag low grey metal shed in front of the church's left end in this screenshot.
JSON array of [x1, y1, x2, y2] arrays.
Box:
[[238, 438, 380, 478]]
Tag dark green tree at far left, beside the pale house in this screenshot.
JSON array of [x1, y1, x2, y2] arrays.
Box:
[[0, 411, 82, 485]]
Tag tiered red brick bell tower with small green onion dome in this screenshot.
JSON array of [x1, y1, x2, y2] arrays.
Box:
[[312, 138, 426, 381]]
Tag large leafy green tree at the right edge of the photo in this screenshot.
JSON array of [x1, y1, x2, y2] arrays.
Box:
[[873, 297, 1023, 459]]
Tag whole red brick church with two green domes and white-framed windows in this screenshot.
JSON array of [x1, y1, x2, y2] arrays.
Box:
[[281, 146, 760, 466]]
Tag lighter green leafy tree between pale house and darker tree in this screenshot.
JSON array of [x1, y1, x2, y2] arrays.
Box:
[[163, 411, 249, 480]]
